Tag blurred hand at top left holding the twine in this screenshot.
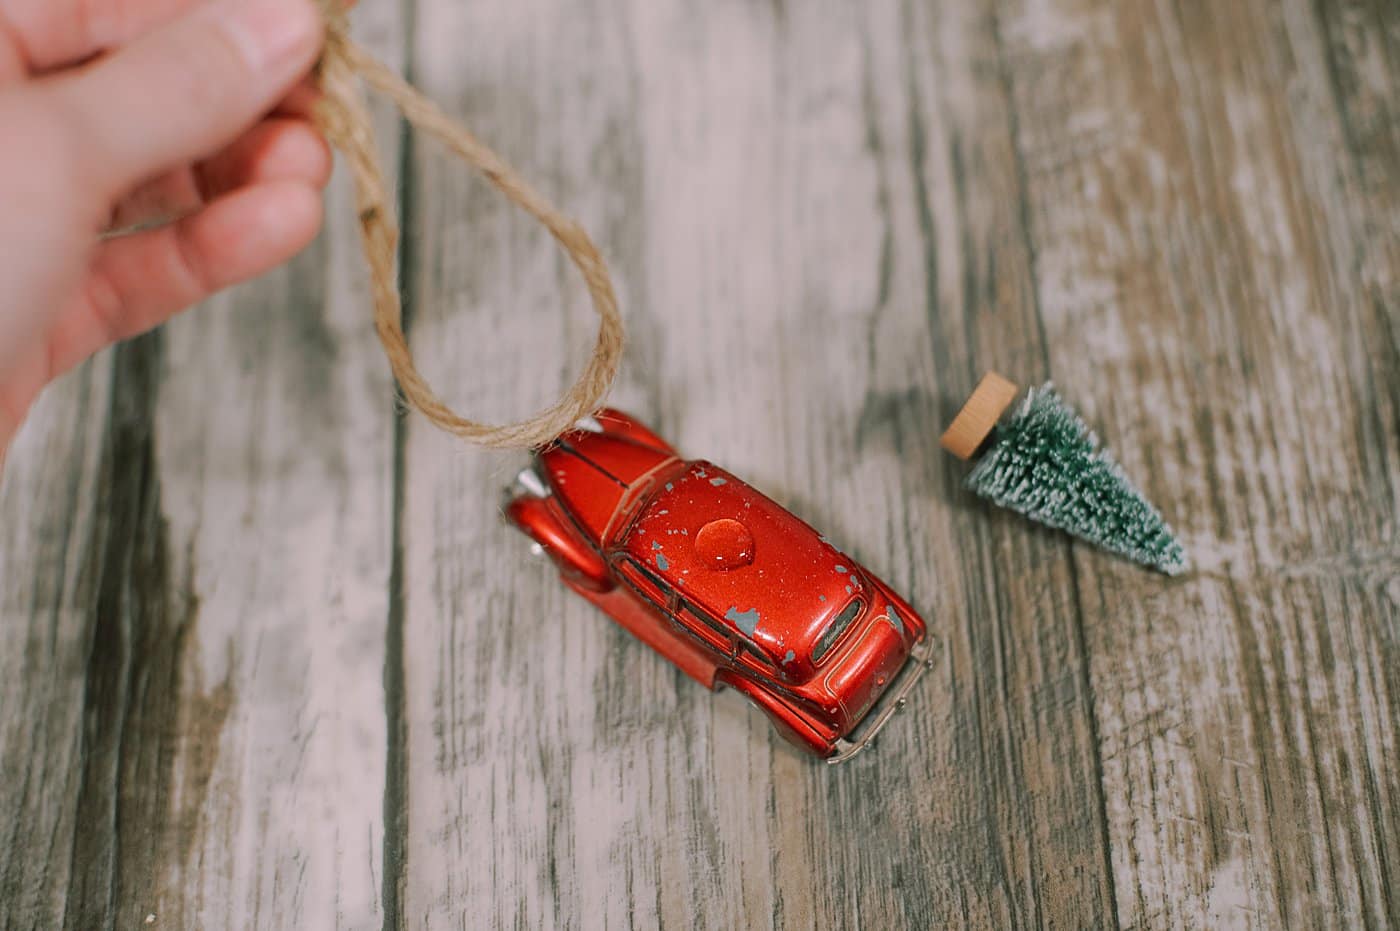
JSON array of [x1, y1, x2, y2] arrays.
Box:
[[0, 0, 330, 458]]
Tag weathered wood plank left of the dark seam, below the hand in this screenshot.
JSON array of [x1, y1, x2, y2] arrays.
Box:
[[0, 3, 402, 930]]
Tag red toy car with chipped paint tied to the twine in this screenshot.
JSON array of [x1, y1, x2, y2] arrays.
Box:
[[505, 410, 930, 763]]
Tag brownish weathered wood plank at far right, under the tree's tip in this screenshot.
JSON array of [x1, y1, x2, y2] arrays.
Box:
[[1001, 1, 1400, 927]]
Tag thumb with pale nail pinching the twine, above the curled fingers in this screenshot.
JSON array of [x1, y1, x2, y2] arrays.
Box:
[[52, 0, 322, 197]]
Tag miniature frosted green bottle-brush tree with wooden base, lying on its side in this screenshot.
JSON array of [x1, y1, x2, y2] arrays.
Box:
[[944, 374, 1187, 575]]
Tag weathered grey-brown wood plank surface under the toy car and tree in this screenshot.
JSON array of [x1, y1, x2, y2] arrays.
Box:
[[0, 0, 1400, 930]]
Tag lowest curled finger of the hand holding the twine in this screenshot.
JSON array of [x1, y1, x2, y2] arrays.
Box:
[[49, 181, 321, 378]]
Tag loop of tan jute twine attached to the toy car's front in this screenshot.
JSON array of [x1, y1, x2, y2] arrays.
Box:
[[316, 0, 623, 448]]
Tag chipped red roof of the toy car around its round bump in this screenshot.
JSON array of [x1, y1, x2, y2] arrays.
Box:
[[616, 461, 864, 678]]
